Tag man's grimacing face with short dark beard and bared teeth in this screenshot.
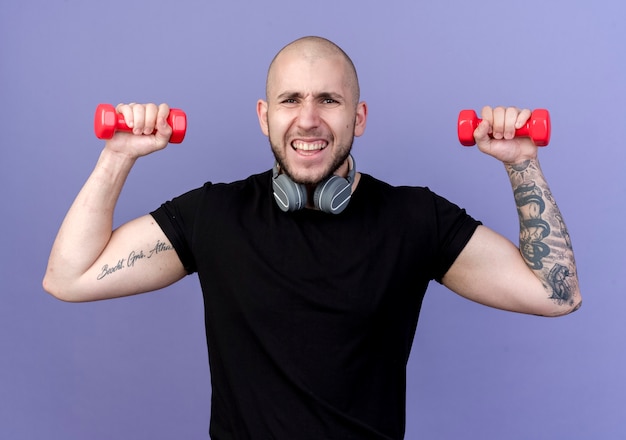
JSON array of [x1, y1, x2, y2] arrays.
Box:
[[257, 51, 367, 185]]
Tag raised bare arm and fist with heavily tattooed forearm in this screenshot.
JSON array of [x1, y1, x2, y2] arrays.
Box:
[[443, 107, 581, 316]]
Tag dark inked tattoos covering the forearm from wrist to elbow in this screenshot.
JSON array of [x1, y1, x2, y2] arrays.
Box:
[[508, 160, 576, 304]]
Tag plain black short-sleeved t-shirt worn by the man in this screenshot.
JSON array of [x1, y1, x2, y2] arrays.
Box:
[[152, 171, 479, 440]]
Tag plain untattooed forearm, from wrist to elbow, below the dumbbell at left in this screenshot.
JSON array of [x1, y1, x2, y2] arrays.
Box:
[[44, 149, 135, 293]]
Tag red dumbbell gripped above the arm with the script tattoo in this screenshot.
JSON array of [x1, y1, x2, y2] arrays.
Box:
[[94, 104, 187, 144]]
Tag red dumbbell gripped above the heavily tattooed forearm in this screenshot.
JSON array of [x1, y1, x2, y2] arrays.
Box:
[[457, 109, 550, 147]]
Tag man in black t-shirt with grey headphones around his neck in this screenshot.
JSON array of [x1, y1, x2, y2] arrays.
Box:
[[44, 37, 581, 439]]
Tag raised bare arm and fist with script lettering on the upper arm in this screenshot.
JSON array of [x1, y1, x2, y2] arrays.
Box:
[[43, 104, 185, 301]]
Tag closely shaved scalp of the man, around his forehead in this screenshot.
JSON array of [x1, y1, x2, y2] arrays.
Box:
[[265, 36, 360, 105]]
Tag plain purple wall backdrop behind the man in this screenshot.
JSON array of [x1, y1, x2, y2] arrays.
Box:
[[0, 0, 626, 440]]
